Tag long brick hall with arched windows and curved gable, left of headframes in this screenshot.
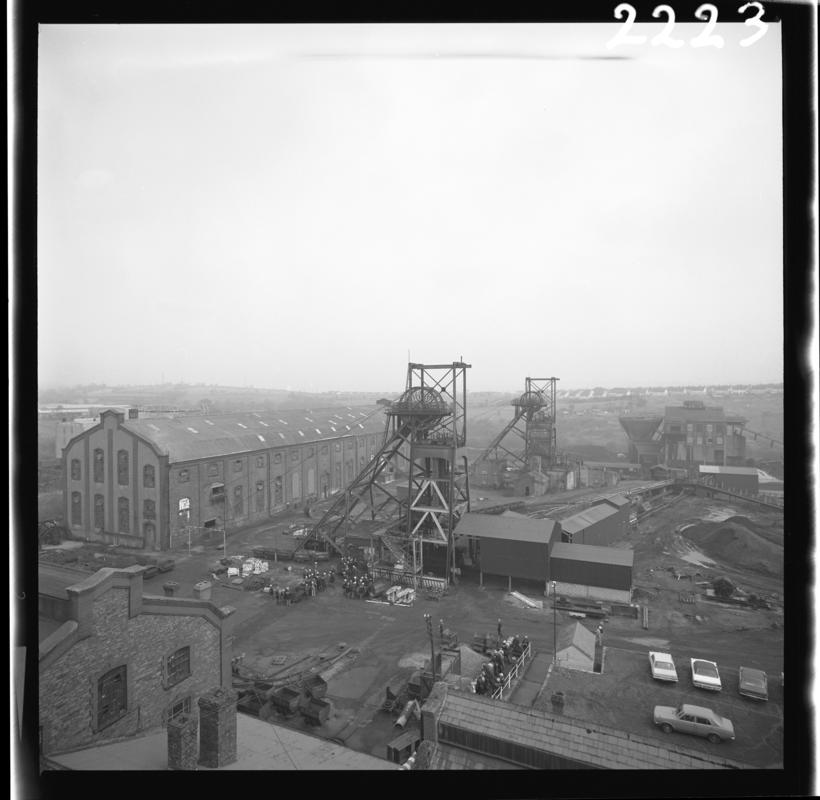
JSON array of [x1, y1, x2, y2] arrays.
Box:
[[62, 406, 392, 550]]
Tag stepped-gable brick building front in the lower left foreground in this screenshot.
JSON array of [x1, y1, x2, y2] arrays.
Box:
[[39, 567, 233, 755]]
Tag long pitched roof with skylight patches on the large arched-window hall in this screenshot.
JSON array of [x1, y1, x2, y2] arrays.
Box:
[[122, 406, 384, 463]]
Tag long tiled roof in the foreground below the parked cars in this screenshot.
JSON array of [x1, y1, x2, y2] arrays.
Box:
[[439, 692, 744, 770]]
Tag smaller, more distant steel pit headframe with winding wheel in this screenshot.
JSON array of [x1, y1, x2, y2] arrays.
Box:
[[473, 378, 559, 482]]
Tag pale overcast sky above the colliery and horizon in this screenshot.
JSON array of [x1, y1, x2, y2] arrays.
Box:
[[38, 22, 782, 391]]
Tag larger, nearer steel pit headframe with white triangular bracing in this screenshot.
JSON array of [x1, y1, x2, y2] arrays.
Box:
[[300, 361, 470, 582]]
